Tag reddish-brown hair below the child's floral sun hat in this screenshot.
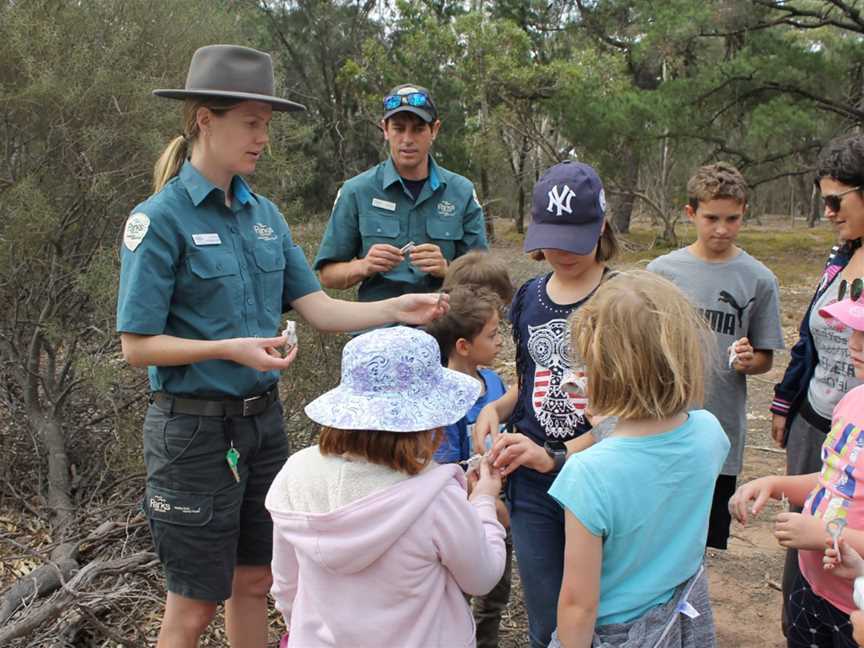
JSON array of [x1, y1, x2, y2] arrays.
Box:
[[318, 427, 444, 475]]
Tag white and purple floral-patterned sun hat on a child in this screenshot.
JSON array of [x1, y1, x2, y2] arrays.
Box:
[[305, 326, 481, 432]]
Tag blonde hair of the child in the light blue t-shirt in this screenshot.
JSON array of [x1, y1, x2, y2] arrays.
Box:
[[570, 271, 711, 419]]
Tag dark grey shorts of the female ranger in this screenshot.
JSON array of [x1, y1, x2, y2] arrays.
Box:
[[144, 400, 288, 601]]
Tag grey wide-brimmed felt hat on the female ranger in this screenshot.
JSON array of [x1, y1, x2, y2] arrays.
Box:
[[153, 45, 306, 111]]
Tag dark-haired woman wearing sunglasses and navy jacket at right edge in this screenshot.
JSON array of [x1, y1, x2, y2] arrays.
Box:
[[771, 135, 864, 633]]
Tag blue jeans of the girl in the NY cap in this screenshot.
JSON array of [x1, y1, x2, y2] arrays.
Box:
[[507, 466, 564, 648]]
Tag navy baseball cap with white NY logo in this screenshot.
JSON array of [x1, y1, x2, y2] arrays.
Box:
[[524, 160, 606, 254]]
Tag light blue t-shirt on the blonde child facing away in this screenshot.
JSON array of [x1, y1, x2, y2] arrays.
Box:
[[549, 410, 729, 625]]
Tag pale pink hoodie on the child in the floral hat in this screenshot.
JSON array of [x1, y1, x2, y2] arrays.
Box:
[[266, 446, 504, 648]]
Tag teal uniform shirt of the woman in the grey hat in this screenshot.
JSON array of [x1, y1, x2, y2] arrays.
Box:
[[117, 162, 321, 397]]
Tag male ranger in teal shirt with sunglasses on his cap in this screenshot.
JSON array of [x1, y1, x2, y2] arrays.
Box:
[[314, 84, 486, 301]]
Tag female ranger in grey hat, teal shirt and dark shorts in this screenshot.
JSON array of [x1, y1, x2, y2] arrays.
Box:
[[117, 45, 446, 648]]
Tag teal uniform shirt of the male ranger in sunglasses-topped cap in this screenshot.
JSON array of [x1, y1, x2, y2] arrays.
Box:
[[314, 156, 486, 301]]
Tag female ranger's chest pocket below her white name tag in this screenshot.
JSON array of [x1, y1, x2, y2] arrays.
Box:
[[185, 250, 242, 318]]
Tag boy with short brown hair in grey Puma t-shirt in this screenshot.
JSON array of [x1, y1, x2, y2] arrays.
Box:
[[648, 162, 783, 549]]
